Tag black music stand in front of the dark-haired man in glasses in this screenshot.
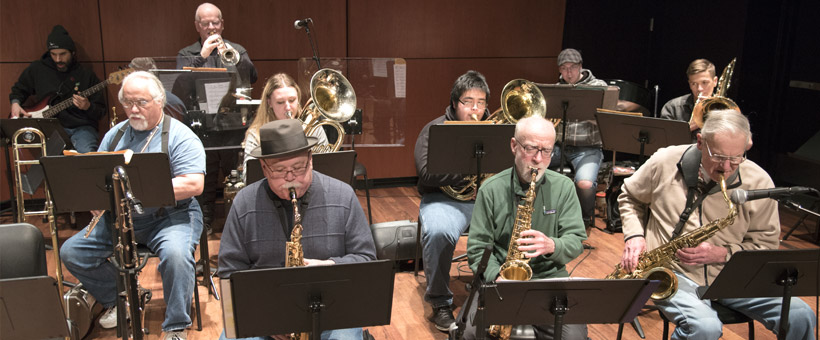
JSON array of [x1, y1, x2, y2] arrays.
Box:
[[427, 124, 515, 192]]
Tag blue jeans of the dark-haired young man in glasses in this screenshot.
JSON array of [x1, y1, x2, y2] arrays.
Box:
[[419, 192, 475, 308]]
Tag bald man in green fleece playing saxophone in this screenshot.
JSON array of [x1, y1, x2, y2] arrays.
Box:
[[464, 116, 587, 339]]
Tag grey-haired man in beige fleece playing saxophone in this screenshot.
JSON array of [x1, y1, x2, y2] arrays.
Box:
[[618, 110, 815, 339]]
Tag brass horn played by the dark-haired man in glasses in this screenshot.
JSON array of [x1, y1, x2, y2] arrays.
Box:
[[441, 79, 547, 202]]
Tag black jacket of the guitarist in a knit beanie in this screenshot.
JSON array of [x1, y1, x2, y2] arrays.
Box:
[[9, 52, 105, 129]]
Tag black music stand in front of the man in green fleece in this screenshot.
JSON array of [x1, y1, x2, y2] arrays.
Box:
[[476, 278, 660, 340]]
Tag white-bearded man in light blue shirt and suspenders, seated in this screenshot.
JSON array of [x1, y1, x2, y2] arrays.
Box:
[[60, 72, 205, 340]]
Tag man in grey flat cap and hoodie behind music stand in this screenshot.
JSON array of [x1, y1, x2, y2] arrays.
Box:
[[552, 48, 606, 234]]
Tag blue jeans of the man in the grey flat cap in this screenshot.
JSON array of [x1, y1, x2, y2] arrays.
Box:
[[550, 144, 604, 226]]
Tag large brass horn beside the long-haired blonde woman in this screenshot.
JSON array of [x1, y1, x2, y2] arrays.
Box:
[[295, 68, 356, 153]]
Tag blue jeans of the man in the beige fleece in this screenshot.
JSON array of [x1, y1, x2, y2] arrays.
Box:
[[655, 273, 815, 339]]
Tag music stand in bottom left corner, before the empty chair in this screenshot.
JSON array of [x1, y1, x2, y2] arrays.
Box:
[[0, 276, 69, 340]]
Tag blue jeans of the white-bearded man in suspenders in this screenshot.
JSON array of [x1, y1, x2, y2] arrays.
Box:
[[60, 199, 202, 331]]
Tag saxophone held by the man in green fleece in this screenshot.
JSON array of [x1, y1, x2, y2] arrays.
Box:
[[488, 167, 538, 340]]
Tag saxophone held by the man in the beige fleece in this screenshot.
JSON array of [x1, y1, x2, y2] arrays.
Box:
[[606, 175, 737, 300]]
